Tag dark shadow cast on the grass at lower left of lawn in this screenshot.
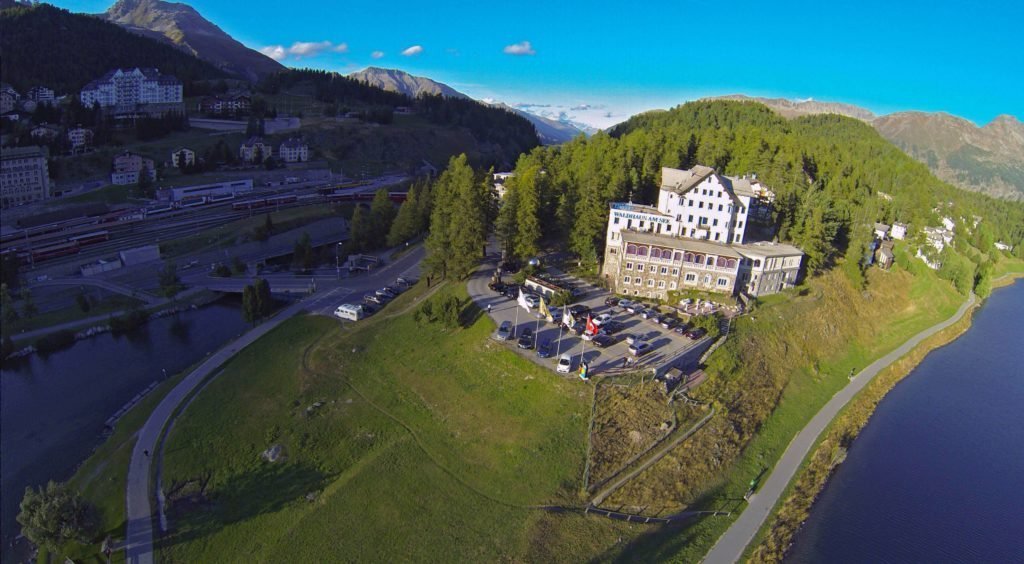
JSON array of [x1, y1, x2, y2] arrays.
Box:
[[155, 463, 328, 550]]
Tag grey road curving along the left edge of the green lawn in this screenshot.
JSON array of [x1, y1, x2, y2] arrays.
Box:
[[125, 247, 424, 564]]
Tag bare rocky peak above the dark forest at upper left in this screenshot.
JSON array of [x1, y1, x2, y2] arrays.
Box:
[[100, 0, 285, 82]]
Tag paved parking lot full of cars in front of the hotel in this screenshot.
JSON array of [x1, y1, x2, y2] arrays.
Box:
[[468, 247, 711, 376]]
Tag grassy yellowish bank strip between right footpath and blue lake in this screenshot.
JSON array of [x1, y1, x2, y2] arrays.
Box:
[[742, 271, 1024, 562]]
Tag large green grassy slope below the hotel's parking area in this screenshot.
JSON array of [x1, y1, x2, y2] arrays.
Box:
[[161, 287, 643, 562]]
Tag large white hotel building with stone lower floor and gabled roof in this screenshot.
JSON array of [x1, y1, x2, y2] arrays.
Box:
[[602, 166, 803, 300]]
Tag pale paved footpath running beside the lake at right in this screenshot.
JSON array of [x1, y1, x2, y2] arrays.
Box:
[[703, 292, 977, 564]]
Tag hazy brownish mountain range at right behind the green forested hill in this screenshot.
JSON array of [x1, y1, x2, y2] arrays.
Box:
[[712, 94, 1024, 200]]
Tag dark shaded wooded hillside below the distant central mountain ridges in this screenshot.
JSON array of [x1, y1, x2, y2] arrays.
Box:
[[257, 70, 540, 167]]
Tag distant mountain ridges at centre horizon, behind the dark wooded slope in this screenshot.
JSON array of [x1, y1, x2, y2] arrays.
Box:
[[348, 67, 581, 145]]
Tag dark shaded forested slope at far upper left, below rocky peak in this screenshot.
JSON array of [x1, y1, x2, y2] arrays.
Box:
[[0, 4, 226, 94]]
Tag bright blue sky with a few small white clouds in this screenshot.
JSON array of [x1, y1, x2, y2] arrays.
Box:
[[56, 0, 1024, 127]]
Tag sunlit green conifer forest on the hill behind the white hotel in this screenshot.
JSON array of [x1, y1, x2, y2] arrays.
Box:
[[499, 100, 1024, 280]]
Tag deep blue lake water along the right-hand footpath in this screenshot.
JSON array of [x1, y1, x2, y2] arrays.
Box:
[[786, 279, 1024, 563]]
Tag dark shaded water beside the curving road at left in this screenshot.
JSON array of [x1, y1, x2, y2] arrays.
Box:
[[0, 298, 246, 561]]
